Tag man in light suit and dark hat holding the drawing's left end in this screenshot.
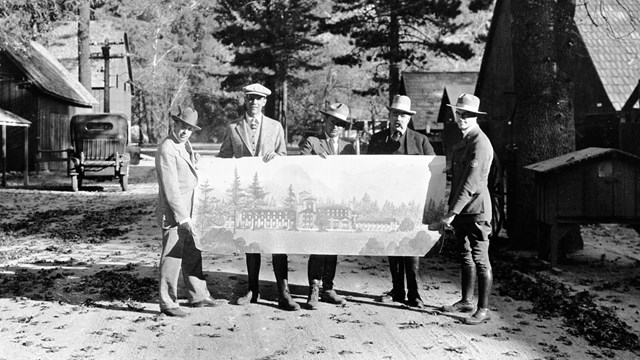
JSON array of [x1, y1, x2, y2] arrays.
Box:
[[156, 108, 217, 317]]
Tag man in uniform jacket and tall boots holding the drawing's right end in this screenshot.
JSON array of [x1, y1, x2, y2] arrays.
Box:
[[442, 94, 493, 325]]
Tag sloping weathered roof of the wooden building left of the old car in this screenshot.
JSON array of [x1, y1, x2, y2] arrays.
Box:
[[4, 41, 98, 107]]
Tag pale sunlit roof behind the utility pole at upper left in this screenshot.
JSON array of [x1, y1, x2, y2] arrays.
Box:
[[47, 21, 132, 88]]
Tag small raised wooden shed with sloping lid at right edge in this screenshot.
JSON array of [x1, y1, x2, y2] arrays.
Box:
[[525, 147, 640, 265]]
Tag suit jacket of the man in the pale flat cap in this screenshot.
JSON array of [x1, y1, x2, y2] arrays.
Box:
[[218, 115, 287, 158]]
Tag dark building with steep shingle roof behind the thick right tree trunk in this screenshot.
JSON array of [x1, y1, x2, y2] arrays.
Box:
[[475, 0, 640, 159]]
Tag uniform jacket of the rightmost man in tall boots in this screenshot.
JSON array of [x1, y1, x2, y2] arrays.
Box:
[[449, 126, 493, 221]]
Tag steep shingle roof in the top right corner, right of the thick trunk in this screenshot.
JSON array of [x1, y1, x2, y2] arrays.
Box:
[[575, 0, 640, 110]]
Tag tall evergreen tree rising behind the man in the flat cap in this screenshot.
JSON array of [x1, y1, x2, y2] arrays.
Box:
[[214, 0, 322, 134]]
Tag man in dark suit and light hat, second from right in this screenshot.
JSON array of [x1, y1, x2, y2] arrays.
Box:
[[367, 95, 435, 308]]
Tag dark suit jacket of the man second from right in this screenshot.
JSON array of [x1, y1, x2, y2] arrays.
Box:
[[367, 129, 436, 155]]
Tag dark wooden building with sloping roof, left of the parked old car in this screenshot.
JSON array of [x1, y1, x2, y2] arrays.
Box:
[[0, 42, 97, 171]]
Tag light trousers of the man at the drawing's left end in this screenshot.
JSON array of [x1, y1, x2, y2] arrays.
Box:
[[159, 226, 210, 310]]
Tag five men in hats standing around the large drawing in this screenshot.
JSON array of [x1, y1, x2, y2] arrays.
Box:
[[156, 84, 493, 324]]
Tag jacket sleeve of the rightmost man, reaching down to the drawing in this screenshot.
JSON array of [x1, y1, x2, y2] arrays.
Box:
[[449, 141, 493, 214]]
